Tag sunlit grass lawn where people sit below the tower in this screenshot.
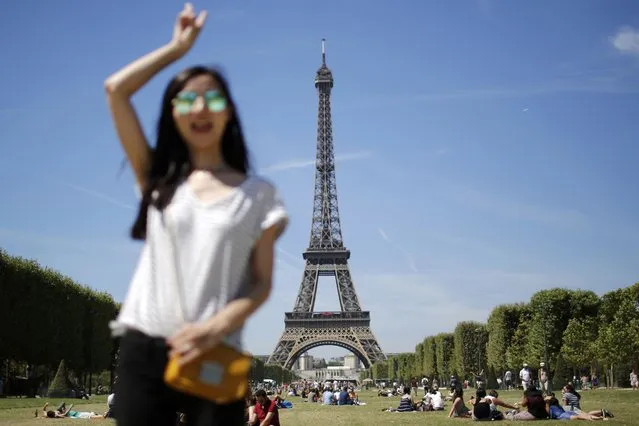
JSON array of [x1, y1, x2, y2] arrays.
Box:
[[0, 390, 639, 426]]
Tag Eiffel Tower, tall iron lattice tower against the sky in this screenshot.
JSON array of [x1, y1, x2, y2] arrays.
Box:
[[267, 40, 386, 368]]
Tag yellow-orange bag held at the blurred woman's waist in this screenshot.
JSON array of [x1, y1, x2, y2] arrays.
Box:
[[164, 344, 252, 404]]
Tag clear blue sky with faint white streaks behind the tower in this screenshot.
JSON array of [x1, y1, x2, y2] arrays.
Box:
[[0, 0, 639, 355]]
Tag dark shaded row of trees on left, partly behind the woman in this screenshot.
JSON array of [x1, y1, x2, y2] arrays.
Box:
[[0, 249, 294, 393]]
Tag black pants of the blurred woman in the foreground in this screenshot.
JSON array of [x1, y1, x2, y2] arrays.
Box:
[[115, 331, 245, 426]]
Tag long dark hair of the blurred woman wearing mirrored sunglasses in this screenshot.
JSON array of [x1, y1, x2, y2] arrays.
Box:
[[131, 65, 250, 240]]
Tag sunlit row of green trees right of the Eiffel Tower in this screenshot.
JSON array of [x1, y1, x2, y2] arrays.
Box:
[[369, 283, 639, 386]]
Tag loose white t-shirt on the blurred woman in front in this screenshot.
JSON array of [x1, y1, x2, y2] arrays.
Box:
[[111, 177, 288, 349]]
